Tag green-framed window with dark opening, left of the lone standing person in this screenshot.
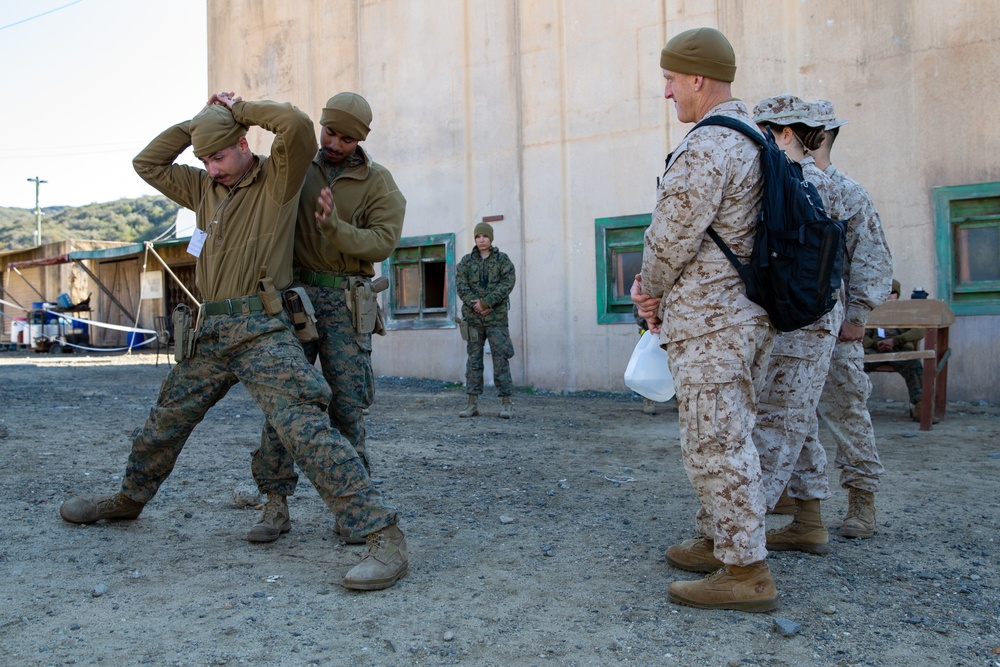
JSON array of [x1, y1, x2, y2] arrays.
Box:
[[382, 234, 457, 329]]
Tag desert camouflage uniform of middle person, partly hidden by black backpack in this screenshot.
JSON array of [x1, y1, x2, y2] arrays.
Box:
[[753, 157, 847, 508]]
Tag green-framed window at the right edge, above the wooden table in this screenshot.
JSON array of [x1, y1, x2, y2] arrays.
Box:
[[934, 183, 1000, 315]]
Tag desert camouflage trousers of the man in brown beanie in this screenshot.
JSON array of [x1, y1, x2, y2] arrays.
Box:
[[667, 321, 775, 565]]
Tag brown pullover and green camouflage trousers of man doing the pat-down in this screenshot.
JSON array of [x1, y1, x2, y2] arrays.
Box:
[[251, 146, 406, 496]]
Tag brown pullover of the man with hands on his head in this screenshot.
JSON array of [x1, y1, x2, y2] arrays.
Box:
[[132, 102, 316, 301]]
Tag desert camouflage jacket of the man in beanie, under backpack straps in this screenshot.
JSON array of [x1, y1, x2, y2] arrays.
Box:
[[642, 100, 769, 344]]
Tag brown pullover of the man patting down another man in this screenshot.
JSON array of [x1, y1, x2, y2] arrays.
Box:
[[295, 146, 406, 278]]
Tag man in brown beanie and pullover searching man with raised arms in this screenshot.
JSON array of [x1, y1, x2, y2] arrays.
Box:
[[247, 92, 406, 544]]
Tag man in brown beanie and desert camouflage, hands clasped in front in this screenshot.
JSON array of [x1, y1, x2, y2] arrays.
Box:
[[632, 28, 778, 612]]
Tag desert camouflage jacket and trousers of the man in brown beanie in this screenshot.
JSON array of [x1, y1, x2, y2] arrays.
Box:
[[642, 100, 774, 565]]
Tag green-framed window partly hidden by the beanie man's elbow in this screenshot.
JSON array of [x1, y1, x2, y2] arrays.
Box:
[[594, 213, 653, 324]]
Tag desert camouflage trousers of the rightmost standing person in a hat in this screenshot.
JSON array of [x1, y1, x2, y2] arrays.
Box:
[[815, 341, 885, 493]]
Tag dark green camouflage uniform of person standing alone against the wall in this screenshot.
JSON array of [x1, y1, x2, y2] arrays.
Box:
[[455, 246, 515, 396]]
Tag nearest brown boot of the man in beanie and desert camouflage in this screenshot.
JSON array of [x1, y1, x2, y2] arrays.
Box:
[[669, 561, 778, 613]]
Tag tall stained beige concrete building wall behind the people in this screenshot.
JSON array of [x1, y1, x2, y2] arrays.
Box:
[[208, 0, 1000, 402]]
